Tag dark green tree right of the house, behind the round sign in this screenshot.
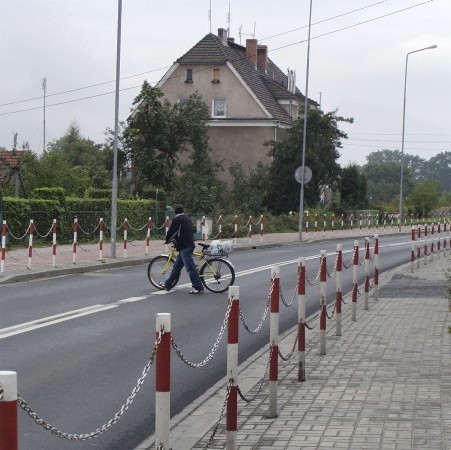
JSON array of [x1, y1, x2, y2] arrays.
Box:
[[266, 109, 353, 214]]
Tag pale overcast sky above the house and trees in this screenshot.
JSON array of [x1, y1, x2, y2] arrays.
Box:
[[0, 0, 451, 165]]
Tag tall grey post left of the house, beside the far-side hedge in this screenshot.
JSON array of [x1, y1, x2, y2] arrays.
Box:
[[111, 0, 122, 258]]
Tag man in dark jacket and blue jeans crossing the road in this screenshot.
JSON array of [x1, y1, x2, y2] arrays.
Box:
[[164, 205, 204, 294]]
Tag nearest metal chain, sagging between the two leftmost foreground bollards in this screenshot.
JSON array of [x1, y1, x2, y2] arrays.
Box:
[[17, 327, 164, 441]]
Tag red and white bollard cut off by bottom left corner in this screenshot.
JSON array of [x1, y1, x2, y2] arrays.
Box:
[[0, 371, 19, 450]]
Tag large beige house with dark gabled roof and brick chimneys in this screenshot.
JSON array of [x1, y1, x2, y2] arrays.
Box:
[[156, 28, 318, 179]]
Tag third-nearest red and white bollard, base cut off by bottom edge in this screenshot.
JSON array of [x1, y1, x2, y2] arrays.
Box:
[[226, 286, 240, 449]]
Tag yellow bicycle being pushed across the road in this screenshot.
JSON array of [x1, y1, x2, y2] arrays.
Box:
[[147, 242, 235, 293]]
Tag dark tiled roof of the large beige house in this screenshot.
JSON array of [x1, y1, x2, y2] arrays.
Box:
[[176, 33, 310, 124]]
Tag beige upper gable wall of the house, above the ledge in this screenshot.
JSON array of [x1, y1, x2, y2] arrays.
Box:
[[161, 64, 268, 119]]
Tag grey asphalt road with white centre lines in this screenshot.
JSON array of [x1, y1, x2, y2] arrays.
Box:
[[0, 236, 410, 450]]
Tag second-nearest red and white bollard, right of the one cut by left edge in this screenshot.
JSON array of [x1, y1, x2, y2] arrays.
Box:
[[155, 313, 171, 448]]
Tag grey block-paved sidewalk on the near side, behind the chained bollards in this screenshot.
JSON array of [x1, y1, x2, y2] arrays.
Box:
[[138, 251, 451, 450]]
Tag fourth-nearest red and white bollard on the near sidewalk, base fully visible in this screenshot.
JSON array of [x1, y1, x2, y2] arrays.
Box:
[[268, 267, 280, 418]]
